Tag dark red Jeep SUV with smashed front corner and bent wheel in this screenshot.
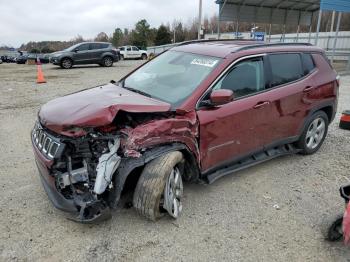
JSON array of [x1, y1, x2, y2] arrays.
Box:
[[32, 41, 339, 222]]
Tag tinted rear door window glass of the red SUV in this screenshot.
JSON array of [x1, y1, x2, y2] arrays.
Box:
[[269, 54, 304, 87]]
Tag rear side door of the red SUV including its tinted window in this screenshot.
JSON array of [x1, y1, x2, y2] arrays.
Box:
[[261, 53, 315, 146]]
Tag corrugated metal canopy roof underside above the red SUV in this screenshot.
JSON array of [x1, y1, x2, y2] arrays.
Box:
[[216, 0, 320, 25]]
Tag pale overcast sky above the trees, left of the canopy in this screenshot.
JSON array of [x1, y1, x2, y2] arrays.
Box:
[[0, 0, 218, 47]]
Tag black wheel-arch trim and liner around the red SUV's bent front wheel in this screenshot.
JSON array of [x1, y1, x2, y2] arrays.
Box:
[[108, 143, 200, 208]]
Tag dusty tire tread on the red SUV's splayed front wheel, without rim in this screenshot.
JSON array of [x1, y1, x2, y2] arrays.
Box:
[[133, 151, 183, 221]]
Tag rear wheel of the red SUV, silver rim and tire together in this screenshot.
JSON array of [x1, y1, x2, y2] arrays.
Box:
[[297, 111, 329, 155]]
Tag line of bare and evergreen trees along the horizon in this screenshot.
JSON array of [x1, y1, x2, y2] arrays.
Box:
[[4, 12, 350, 53]]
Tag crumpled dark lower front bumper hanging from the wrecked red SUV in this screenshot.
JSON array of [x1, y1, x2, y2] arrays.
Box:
[[32, 135, 111, 223]]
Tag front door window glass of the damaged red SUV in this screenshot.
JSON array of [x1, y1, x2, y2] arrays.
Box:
[[213, 57, 265, 98]]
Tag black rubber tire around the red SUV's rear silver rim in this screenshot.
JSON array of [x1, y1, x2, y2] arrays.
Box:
[[297, 111, 329, 155]]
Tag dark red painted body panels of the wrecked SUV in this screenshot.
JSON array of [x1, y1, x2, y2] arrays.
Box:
[[33, 41, 338, 174]]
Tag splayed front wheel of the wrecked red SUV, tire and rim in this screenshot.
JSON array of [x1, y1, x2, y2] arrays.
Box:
[[133, 151, 184, 221]]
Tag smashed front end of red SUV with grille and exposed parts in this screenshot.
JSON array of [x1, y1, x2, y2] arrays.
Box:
[[32, 123, 121, 223]]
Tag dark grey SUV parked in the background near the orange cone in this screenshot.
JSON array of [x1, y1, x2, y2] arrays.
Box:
[[50, 42, 119, 69]]
